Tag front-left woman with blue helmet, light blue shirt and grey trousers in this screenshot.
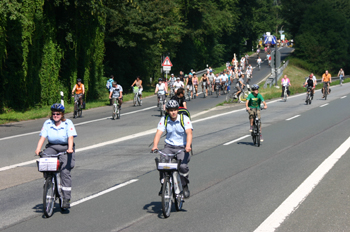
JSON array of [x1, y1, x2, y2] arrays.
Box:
[[35, 103, 77, 208]]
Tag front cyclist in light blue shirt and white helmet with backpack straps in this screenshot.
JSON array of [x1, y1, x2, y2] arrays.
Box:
[[152, 100, 193, 198]]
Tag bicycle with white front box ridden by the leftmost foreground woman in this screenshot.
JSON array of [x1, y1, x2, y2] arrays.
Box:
[[36, 152, 68, 218]]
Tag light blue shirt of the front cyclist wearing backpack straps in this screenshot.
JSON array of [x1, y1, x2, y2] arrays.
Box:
[[157, 114, 193, 146]]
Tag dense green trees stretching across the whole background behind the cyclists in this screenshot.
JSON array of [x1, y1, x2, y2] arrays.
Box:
[[0, 0, 350, 111]]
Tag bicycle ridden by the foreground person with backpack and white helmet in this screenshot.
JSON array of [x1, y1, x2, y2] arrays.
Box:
[[153, 150, 184, 218]]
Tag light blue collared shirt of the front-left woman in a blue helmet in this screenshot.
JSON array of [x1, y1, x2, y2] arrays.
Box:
[[40, 119, 77, 145]]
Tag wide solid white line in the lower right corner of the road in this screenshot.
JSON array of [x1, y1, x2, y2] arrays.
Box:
[[254, 137, 350, 232]]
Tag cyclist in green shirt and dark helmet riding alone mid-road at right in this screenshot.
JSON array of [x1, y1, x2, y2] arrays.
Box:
[[245, 84, 267, 142]]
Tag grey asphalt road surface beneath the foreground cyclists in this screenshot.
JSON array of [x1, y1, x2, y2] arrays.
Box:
[[4, 47, 350, 231]]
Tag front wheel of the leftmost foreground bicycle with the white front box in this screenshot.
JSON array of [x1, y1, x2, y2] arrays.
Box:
[[43, 176, 56, 218]]
